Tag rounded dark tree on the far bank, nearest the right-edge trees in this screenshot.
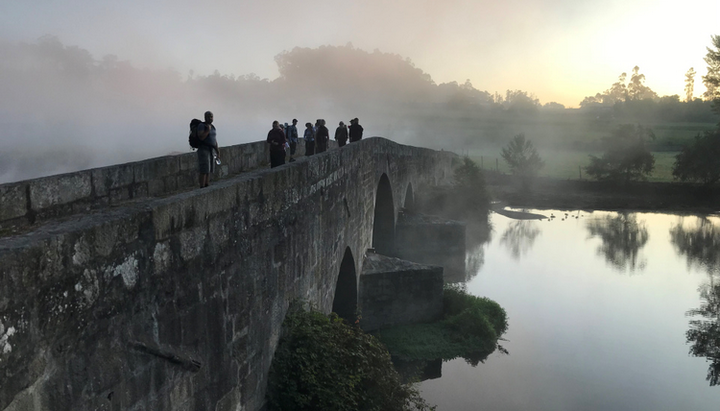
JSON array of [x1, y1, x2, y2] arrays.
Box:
[[585, 124, 655, 182]]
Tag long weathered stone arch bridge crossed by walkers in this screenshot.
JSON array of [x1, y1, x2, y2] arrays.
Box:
[[0, 138, 456, 411]]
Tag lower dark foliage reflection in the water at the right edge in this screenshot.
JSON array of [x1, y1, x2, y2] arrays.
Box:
[[686, 278, 720, 386]]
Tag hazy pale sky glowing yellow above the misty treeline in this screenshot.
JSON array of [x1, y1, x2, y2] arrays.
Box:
[[0, 0, 720, 107]]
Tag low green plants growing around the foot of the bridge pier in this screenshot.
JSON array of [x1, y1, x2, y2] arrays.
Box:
[[376, 286, 507, 365]]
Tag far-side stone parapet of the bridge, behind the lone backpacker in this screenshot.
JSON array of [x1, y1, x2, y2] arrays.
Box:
[[0, 141, 269, 234]]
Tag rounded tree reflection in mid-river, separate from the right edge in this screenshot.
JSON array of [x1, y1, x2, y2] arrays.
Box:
[[587, 213, 648, 271]]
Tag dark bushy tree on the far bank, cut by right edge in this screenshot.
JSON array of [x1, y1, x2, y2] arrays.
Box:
[[673, 129, 720, 185]]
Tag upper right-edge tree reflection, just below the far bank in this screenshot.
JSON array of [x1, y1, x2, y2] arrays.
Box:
[[670, 218, 720, 275]]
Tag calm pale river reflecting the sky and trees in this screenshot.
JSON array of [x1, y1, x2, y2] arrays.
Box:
[[420, 210, 720, 411]]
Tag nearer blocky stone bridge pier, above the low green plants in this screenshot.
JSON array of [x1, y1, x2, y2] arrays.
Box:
[[359, 253, 443, 331]]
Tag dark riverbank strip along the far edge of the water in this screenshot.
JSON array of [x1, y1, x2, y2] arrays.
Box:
[[485, 170, 720, 214]]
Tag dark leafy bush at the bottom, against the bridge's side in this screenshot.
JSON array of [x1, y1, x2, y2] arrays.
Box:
[[268, 304, 432, 411]]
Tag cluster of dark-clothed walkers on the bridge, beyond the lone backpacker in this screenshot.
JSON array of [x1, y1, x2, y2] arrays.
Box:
[[267, 118, 363, 168]]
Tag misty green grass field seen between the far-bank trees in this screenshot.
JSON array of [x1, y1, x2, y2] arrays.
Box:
[[468, 150, 677, 182]]
